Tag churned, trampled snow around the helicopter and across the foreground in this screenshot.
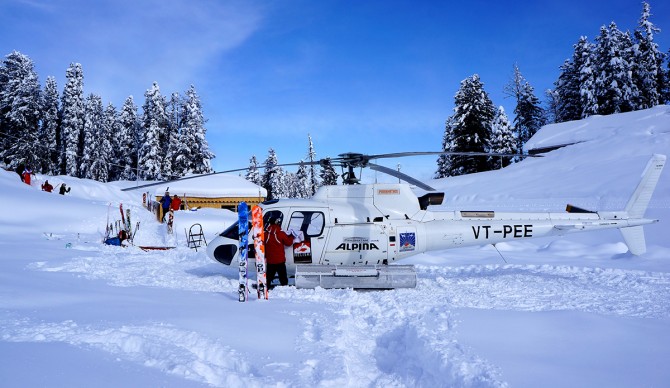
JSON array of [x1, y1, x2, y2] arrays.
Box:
[[14, 242, 670, 387]]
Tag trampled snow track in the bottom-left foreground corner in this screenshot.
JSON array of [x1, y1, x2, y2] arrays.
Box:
[[0, 319, 262, 387]]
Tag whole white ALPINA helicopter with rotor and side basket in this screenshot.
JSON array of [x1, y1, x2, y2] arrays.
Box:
[[201, 152, 666, 289]]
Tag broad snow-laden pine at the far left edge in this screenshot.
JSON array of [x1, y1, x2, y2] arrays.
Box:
[[0, 51, 42, 168]]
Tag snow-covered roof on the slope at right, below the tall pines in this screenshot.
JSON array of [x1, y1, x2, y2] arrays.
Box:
[[525, 105, 670, 151]]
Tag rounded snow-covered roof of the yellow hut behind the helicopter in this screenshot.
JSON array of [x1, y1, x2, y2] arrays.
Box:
[[154, 174, 267, 198]]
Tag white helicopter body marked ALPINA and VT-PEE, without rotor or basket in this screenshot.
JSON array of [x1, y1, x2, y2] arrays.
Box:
[[207, 155, 665, 268]]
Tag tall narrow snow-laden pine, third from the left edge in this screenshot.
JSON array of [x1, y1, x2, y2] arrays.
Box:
[[60, 63, 85, 177]]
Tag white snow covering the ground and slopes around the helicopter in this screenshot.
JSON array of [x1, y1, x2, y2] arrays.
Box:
[[0, 106, 670, 387]]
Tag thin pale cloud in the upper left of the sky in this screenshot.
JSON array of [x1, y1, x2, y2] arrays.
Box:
[[0, 0, 263, 104]]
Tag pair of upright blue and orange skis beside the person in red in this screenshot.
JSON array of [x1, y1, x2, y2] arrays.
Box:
[[237, 202, 268, 302]]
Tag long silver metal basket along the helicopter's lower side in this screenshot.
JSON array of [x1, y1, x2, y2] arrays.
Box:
[[295, 264, 416, 290]]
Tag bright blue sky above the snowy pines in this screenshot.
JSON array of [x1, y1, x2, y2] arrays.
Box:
[[0, 0, 670, 179]]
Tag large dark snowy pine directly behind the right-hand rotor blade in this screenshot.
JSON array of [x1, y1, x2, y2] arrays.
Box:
[[445, 74, 495, 176]]
